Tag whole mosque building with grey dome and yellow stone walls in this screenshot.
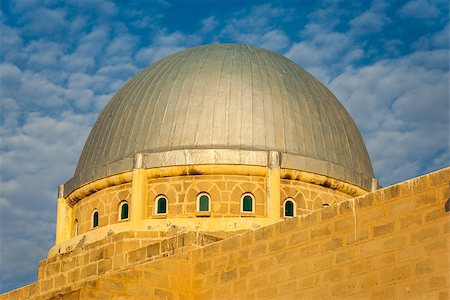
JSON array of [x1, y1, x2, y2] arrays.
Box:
[[0, 44, 450, 299]]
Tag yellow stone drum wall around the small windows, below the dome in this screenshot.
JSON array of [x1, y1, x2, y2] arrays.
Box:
[[72, 171, 351, 236]]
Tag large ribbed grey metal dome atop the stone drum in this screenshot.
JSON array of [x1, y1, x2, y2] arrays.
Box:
[[65, 44, 374, 193]]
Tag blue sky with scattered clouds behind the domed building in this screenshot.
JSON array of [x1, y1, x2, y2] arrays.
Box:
[[0, 0, 450, 293]]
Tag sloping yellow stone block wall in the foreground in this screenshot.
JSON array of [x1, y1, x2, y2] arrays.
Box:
[[0, 168, 450, 299]]
